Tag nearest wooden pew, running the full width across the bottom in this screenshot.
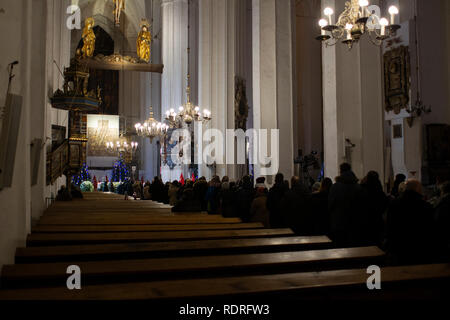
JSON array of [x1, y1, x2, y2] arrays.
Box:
[[0, 264, 450, 303]]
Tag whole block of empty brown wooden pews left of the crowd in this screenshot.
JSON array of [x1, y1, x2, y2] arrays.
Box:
[[0, 193, 450, 302]]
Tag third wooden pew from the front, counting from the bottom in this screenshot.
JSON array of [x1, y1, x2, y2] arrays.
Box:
[[16, 236, 331, 263]]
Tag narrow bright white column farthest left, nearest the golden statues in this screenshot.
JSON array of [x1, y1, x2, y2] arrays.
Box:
[[161, 0, 188, 181]]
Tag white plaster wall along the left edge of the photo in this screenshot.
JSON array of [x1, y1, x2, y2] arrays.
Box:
[[0, 0, 45, 266]]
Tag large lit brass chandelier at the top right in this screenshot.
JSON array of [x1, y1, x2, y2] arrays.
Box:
[[316, 0, 400, 49]]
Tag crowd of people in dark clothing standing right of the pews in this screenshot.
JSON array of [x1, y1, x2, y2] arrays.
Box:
[[134, 163, 450, 263]]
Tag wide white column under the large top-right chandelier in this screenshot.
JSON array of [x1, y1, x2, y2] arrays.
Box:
[[322, 0, 385, 179]]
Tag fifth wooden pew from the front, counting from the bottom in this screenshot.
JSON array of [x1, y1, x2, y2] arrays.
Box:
[[31, 222, 264, 233]]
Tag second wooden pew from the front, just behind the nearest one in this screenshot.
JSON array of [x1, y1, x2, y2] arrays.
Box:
[[1, 247, 384, 288]]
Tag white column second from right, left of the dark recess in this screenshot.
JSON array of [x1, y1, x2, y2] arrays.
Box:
[[253, 0, 294, 183]]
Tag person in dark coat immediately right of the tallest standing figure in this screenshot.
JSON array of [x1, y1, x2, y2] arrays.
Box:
[[361, 171, 388, 245]]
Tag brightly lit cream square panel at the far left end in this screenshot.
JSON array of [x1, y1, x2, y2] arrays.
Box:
[[87, 115, 119, 157]]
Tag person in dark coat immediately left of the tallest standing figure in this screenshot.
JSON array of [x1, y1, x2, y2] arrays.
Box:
[[311, 178, 333, 235]]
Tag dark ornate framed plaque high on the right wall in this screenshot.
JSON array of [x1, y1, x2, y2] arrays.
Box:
[[384, 46, 411, 114]]
